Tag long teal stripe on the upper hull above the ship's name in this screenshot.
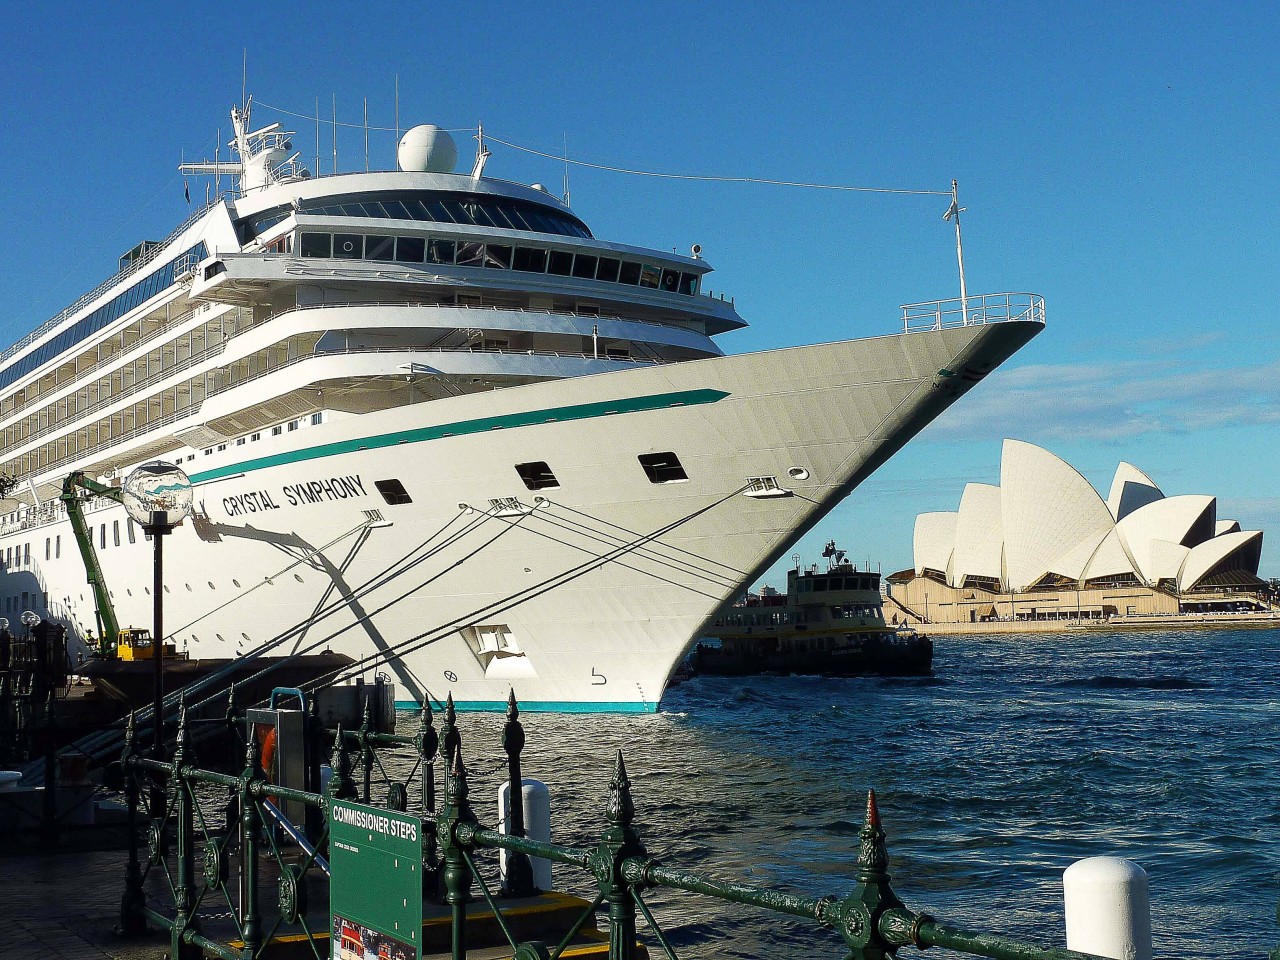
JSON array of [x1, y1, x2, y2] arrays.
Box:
[[191, 389, 728, 484]]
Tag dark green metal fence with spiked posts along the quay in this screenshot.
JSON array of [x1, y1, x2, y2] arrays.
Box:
[[119, 698, 1121, 960]]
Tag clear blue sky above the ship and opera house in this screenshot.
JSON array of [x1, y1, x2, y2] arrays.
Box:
[[0, 3, 1280, 582]]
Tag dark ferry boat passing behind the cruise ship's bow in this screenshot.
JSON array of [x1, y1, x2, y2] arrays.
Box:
[[690, 541, 933, 677]]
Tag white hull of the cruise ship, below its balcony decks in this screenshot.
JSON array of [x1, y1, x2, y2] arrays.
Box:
[[0, 321, 1042, 712]]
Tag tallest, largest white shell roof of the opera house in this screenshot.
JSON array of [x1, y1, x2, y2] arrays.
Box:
[[1000, 440, 1115, 590]]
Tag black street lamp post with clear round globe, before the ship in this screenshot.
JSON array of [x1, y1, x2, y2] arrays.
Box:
[[122, 461, 191, 760]]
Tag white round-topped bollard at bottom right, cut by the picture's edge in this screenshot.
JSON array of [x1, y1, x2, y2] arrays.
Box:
[[1062, 856, 1151, 960]]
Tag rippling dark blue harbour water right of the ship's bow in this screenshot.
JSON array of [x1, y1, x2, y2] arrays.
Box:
[[432, 630, 1280, 957]]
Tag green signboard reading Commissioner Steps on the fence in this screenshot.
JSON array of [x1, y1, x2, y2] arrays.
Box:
[[329, 800, 422, 960]]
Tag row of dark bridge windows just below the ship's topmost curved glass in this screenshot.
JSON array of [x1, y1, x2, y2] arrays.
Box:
[[300, 233, 700, 296]]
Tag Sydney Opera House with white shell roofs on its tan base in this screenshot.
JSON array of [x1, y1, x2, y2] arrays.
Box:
[[884, 440, 1267, 623]]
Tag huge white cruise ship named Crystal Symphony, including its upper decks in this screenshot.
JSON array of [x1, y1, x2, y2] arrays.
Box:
[[0, 102, 1044, 712]]
